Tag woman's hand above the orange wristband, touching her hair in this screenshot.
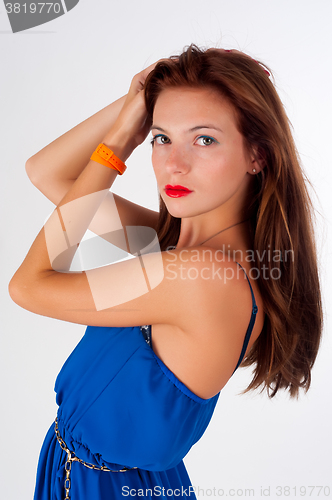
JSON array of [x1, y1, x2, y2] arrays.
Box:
[[102, 61, 163, 161]]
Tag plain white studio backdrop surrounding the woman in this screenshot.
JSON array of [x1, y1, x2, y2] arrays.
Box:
[[0, 0, 332, 500]]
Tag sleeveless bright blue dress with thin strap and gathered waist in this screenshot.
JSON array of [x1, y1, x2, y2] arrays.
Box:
[[34, 264, 258, 500]]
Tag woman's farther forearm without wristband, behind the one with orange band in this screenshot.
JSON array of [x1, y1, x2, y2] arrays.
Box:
[[26, 96, 126, 197]]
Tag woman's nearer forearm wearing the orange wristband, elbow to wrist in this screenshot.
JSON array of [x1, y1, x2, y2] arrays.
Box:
[[10, 129, 131, 286]]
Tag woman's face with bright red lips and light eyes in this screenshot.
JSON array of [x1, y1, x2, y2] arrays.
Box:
[[152, 87, 256, 219]]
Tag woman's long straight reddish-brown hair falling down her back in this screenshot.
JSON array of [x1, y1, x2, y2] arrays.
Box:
[[145, 45, 323, 397]]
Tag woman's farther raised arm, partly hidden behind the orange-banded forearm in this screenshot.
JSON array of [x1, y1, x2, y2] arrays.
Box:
[[26, 87, 159, 242]]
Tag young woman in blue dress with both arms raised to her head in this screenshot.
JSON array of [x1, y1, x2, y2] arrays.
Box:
[[9, 45, 322, 500]]
